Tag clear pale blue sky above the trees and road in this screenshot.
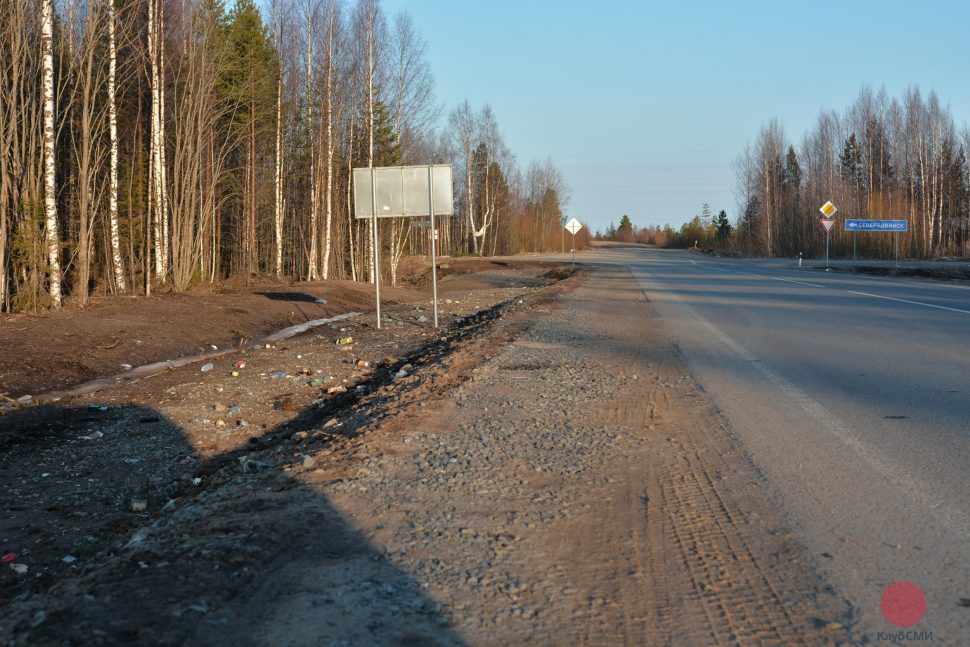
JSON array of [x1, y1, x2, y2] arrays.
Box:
[[383, 0, 970, 230]]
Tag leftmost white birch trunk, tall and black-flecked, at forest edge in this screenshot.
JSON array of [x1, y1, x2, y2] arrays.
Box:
[[40, 0, 62, 308]]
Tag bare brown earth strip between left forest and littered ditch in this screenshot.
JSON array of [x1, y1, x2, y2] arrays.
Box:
[[0, 258, 548, 400]]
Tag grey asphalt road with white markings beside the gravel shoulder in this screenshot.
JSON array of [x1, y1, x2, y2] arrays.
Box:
[[577, 248, 970, 644]]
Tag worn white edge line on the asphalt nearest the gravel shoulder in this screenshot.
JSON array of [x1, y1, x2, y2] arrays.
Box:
[[638, 268, 970, 536]]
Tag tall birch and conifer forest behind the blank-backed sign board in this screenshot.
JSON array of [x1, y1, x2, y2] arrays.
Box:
[[0, 0, 568, 312]]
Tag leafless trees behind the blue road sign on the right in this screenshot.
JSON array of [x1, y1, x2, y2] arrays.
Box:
[[735, 87, 970, 258]]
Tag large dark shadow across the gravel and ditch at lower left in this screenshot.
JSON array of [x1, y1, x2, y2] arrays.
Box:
[[0, 406, 463, 645]]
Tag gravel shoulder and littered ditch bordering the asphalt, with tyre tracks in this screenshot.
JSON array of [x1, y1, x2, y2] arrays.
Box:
[[0, 262, 851, 645]]
